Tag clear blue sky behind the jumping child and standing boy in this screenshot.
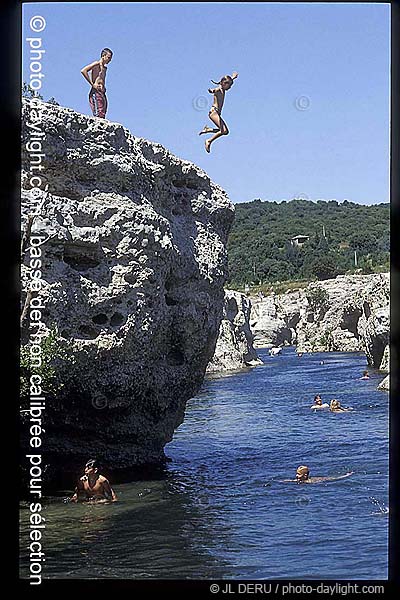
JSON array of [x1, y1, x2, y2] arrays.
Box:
[[23, 2, 390, 204]]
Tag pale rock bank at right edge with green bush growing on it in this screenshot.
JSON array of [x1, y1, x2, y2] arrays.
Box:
[[297, 273, 389, 358]]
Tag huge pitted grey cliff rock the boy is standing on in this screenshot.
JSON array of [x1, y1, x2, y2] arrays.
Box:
[[22, 101, 234, 468]]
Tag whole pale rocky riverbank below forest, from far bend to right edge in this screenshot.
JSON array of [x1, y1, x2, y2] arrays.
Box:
[[250, 273, 390, 386]]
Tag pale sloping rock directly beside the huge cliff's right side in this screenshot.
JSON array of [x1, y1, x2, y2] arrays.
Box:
[[207, 290, 262, 373]]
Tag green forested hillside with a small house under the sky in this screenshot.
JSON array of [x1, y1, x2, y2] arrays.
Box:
[[228, 199, 390, 287]]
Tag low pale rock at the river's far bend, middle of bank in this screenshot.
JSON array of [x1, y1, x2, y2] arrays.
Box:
[[250, 291, 303, 348]]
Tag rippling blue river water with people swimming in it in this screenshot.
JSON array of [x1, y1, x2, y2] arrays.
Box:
[[21, 348, 389, 579]]
